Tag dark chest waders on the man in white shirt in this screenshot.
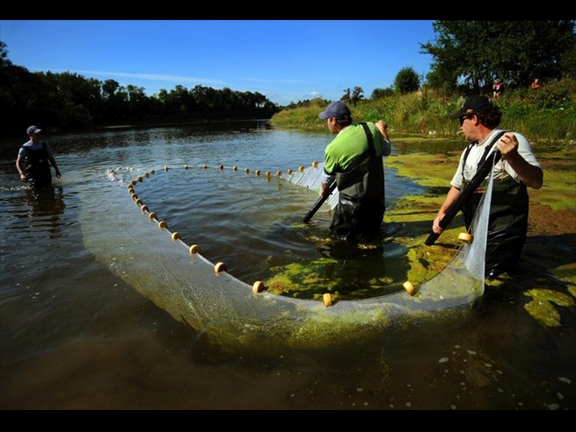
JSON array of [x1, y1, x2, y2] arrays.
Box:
[[462, 132, 529, 269]]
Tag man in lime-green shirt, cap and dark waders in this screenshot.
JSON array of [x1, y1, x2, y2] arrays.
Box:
[[319, 101, 391, 241]]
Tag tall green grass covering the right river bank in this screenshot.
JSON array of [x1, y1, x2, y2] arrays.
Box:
[[271, 80, 576, 143]]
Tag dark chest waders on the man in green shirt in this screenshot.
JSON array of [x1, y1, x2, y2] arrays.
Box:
[[330, 122, 384, 240]]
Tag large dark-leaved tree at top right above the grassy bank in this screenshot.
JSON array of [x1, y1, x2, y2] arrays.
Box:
[[420, 20, 575, 93]]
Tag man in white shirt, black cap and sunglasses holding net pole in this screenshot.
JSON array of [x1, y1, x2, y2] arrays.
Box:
[[432, 96, 544, 279]]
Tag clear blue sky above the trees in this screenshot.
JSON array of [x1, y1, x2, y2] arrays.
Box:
[[0, 20, 436, 105]]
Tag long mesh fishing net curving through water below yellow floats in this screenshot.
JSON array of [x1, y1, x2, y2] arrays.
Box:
[[82, 163, 492, 351]]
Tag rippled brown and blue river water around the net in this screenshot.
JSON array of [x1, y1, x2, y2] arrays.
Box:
[[0, 121, 576, 410]]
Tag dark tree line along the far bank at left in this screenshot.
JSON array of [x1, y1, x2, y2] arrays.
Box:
[[0, 41, 280, 136]]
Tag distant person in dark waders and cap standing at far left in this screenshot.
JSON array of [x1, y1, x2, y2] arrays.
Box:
[[16, 126, 61, 188]]
